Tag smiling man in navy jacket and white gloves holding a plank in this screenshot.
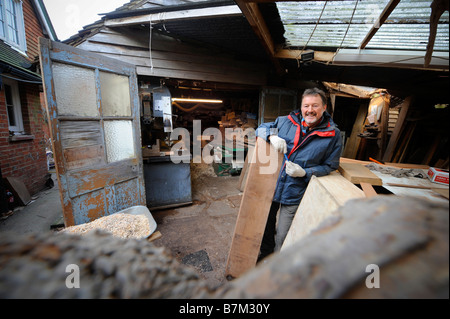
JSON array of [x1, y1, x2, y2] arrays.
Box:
[[256, 88, 342, 260]]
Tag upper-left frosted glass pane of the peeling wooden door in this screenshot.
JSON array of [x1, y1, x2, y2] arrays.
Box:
[[53, 63, 99, 117]]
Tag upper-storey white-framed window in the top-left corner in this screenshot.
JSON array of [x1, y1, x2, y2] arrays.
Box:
[[0, 0, 27, 52]]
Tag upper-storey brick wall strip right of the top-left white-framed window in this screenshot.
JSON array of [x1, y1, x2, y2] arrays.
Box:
[[22, 0, 44, 61]]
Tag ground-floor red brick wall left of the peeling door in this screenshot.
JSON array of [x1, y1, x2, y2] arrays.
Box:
[[0, 83, 47, 194]]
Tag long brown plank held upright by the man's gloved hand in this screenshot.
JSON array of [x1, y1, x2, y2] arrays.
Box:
[[225, 138, 282, 279]]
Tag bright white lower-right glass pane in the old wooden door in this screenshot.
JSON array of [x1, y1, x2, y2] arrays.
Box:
[[104, 121, 135, 163]]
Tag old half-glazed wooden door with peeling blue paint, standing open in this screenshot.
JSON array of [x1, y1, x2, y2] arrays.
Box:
[[40, 39, 145, 226]]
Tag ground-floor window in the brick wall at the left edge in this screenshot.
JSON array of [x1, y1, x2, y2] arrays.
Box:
[[2, 78, 23, 134]]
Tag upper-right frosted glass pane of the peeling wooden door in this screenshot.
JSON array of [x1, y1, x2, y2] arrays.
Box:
[[100, 72, 131, 116]]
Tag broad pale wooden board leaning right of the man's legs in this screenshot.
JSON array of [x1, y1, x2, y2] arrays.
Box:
[[281, 172, 365, 250]]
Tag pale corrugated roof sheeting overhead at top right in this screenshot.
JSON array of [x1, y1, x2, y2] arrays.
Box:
[[277, 0, 449, 52]]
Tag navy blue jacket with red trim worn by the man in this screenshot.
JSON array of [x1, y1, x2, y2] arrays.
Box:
[[256, 111, 342, 205]]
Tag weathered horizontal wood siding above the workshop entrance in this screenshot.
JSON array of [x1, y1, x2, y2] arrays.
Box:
[[77, 27, 267, 86]]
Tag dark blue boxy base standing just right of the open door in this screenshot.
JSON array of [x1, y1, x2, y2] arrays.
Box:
[[143, 155, 192, 211]]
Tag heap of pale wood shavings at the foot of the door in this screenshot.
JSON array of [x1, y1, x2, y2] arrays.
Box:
[[61, 213, 150, 238]]
